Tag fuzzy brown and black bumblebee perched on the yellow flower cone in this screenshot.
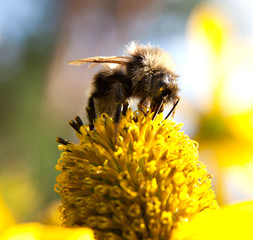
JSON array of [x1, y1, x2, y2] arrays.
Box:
[[69, 42, 179, 130]]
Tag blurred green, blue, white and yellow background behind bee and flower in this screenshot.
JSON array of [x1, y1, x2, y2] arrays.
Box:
[[0, 0, 253, 223]]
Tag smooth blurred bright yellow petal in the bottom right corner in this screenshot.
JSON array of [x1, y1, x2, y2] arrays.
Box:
[[172, 202, 253, 240]]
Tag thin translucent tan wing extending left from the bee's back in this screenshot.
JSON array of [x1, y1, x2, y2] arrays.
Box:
[[68, 56, 131, 66]]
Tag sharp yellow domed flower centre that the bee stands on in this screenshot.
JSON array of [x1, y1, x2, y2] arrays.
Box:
[[56, 109, 217, 240]]
